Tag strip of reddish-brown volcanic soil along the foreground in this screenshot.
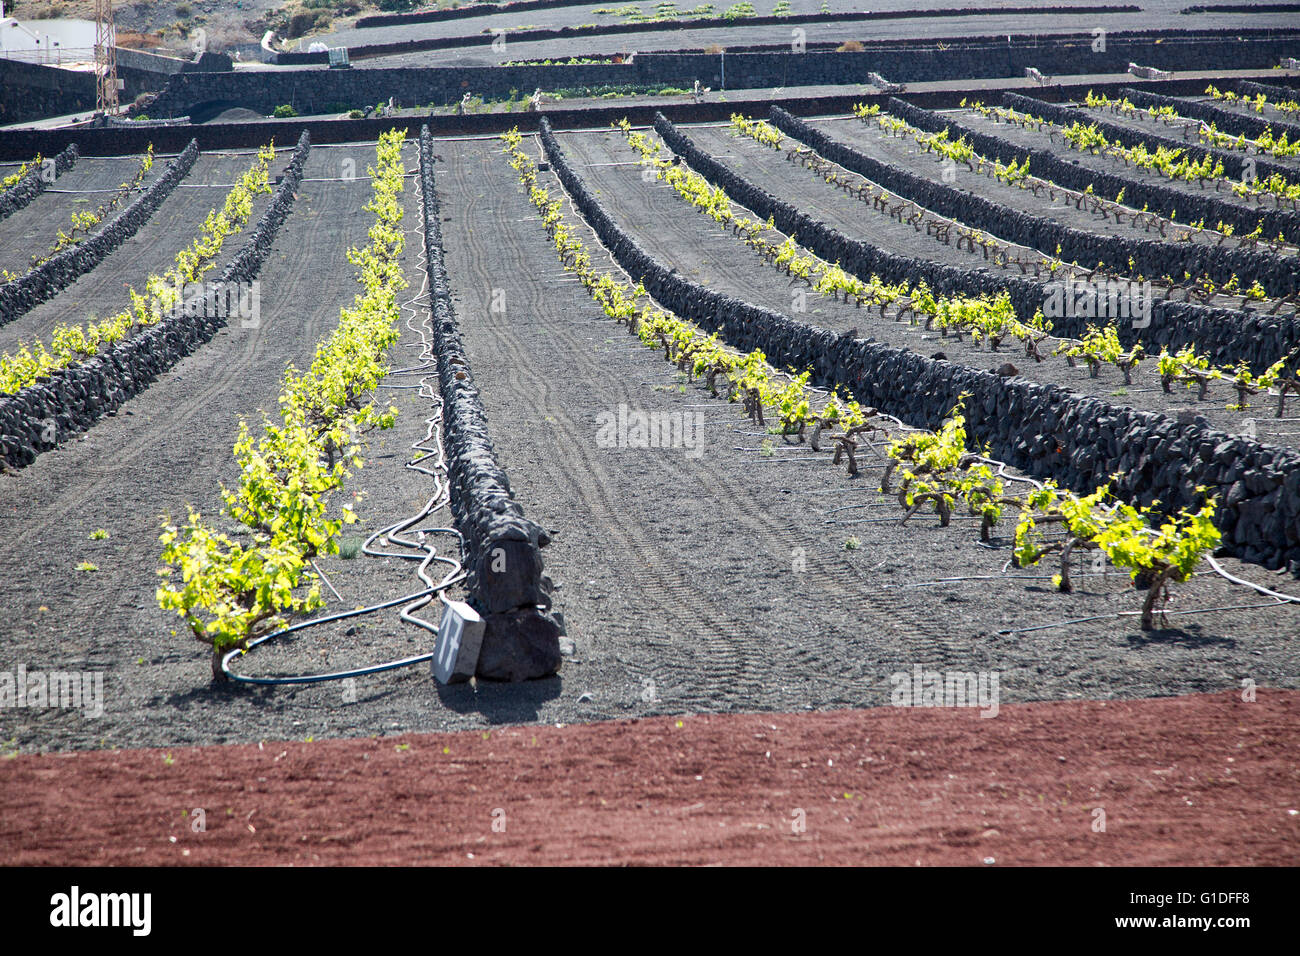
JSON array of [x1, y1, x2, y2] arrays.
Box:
[[0, 691, 1300, 866]]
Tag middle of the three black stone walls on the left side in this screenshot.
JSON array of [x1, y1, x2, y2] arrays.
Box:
[[0, 139, 199, 325]]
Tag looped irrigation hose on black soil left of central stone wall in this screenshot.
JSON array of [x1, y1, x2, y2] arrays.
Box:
[[221, 155, 467, 685]]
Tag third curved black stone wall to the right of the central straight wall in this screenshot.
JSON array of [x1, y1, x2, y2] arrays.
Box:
[[772, 107, 1300, 297]]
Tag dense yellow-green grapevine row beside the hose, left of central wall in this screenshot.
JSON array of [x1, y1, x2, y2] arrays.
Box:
[[157, 130, 406, 678]]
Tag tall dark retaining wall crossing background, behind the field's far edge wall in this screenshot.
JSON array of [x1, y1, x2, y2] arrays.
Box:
[[142, 34, 1296, 117]]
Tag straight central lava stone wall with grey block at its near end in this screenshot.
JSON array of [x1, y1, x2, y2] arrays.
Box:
[[420, 126, 560, 680]]
